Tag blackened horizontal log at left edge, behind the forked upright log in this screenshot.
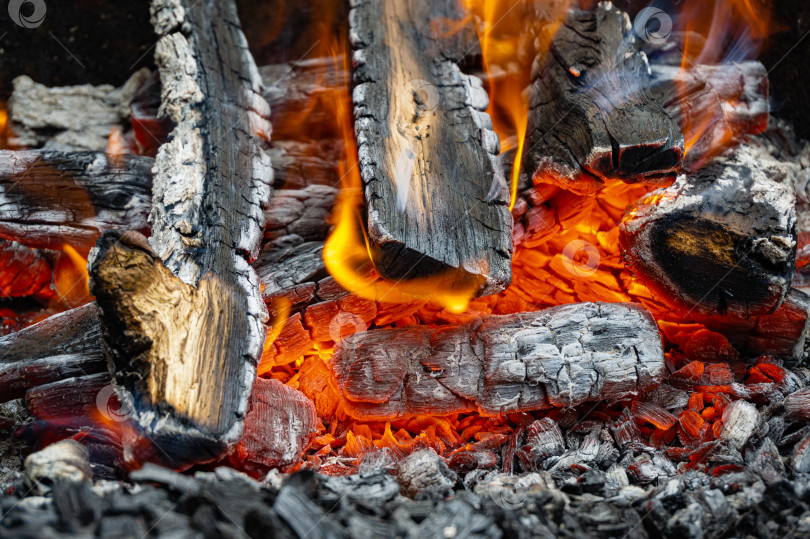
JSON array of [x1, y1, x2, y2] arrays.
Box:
[[0, 151, 154, 254]]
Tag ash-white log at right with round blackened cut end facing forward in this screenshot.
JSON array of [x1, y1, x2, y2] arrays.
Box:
[[619, 147, 796, 317]]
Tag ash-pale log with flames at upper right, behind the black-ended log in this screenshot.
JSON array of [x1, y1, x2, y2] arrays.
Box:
[[650, 62, 770, 169]]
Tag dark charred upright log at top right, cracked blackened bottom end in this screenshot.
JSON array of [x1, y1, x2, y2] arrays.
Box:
[[524, 2, 684, 194]]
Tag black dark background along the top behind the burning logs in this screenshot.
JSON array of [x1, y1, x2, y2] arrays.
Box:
[[0, 0, 810, 139]]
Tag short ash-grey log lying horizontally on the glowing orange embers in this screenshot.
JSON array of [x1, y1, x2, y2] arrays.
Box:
[[330, 303, 665, 419]]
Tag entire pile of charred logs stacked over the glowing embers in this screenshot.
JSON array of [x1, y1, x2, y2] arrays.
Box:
[[0, 0, 810, 524]]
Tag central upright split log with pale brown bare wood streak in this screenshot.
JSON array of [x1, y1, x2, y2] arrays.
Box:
[[349, 0, 512, 294]]
